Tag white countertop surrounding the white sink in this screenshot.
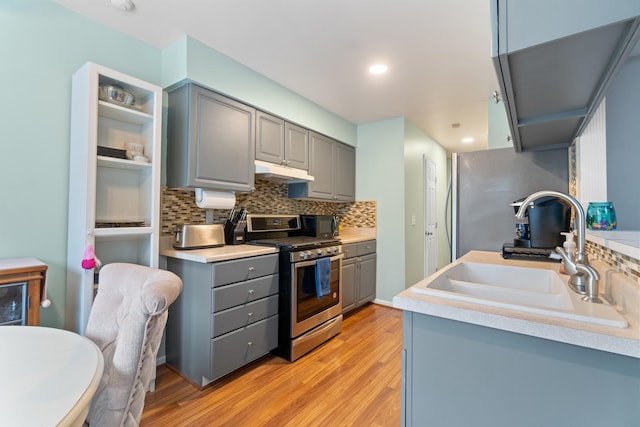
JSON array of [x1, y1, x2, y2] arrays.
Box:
[[393, 251, 640, 358]]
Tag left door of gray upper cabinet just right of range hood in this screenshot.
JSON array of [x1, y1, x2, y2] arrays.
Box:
[[307, 132, 336, 200]]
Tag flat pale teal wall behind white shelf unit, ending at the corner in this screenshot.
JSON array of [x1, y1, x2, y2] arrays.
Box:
[[0, 0, 160, 327]]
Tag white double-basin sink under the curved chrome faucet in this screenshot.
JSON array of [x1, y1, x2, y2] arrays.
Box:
[[411, 262, 628, 328]]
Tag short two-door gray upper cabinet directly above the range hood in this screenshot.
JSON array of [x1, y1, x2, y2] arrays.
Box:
[[256, 111, 309, 170]]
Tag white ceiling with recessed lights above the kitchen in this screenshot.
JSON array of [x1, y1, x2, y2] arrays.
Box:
[[55, 0, 498, 151]]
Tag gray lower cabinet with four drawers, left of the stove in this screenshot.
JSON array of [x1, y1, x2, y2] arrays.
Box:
[[166, 254, 279, 386]]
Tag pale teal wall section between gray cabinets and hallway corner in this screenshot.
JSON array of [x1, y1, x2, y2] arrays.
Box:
[[356, 117, 405, 303]]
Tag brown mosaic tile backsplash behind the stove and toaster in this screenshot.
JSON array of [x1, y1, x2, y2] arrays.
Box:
[[161, 180, 376, 236]]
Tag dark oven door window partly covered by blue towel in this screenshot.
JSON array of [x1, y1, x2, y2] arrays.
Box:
[[295, 259, 342, 323]]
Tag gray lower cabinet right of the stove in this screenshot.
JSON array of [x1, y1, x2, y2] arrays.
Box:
[[342, 240, 376, 314]]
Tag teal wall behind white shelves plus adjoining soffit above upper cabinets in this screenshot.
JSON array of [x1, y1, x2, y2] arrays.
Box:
[[0, 0, 357, 328]]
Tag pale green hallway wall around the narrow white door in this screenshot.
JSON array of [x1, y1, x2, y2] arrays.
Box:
[[404, 120, 451, 287]]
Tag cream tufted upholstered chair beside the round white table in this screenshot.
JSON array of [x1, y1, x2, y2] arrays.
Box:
[[85, 263, 182, 427]]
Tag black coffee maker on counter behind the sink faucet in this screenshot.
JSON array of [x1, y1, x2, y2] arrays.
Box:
[[502, 197, 571, 259]]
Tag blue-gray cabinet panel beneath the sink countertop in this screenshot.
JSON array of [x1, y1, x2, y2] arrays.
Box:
[[401, 311, 640, 427]]
